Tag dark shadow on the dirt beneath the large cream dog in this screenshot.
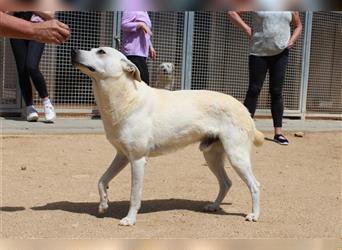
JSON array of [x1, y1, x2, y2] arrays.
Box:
[[31, 199, 246, 219]]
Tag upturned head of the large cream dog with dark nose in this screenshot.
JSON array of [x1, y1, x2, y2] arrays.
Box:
[[71, 47, 141, 82]]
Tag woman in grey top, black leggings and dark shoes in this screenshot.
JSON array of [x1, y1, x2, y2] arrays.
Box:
[[228, 11, 302, 145]]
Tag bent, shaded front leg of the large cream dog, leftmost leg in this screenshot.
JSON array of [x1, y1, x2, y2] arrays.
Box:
[[98, 153, 129, 214]]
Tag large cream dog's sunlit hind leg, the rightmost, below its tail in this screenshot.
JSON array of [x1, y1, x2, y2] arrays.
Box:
[[221, 131, 260, 221]]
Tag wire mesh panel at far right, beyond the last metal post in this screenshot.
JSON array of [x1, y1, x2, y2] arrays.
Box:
[[307, 12, 342, 114]]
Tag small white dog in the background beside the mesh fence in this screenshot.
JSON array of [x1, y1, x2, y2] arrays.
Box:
[[156, 62, 175, 90]]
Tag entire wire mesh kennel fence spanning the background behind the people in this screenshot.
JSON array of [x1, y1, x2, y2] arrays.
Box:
[[0, 11, 342, 116]]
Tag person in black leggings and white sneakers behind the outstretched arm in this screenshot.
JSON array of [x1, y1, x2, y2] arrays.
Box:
[[10, 12, 56, 122]]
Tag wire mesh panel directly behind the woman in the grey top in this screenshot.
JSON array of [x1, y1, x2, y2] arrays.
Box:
[[191, 11, 304, 114]]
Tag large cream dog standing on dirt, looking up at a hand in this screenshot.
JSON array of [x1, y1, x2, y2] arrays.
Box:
[[72, 47, 264, 225]]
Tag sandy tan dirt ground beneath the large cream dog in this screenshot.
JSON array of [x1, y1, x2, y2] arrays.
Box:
[[0, 133, 342, 239]]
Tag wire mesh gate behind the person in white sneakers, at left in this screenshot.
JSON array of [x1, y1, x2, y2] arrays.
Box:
[[0, 11, 116, 113]]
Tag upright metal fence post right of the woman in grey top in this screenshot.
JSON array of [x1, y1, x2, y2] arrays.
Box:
[[300, 11, 313, 120]]
